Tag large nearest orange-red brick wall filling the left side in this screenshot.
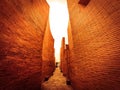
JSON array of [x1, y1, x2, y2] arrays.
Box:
[[0, 0, 49, 90]]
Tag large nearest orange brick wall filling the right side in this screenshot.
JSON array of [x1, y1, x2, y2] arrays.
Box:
[[67, 0, 120, 90]]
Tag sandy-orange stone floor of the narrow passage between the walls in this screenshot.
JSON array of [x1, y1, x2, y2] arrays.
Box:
[[42, 68, 73, 90]]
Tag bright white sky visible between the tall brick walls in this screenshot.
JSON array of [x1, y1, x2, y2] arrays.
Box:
[[47, 0, 69, 61]]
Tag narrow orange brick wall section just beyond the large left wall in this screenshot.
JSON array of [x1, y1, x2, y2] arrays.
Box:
[[42, 21, 55, 79]]
